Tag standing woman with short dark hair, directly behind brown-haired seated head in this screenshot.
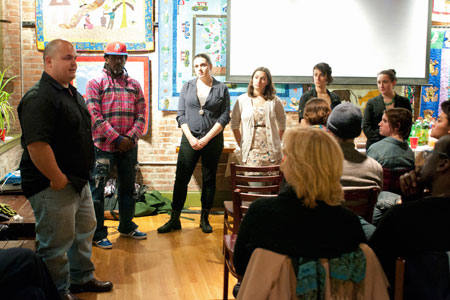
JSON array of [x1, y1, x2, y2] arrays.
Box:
[[298, 62, 341, 124]]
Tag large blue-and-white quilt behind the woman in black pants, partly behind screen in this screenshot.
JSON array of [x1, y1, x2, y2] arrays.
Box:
[[158, 0, 303, 111]]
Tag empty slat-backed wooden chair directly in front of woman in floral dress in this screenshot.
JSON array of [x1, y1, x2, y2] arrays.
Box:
[[223, 163, 283, 235]]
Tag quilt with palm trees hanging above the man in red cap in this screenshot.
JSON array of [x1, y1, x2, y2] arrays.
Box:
[[36, 0, 155, 51]]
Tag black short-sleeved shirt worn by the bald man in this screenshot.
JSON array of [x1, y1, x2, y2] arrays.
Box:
[[17, 72, 94, 197]]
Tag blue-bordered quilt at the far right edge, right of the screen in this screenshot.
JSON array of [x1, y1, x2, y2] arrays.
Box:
[[420, 28, 450, 118]]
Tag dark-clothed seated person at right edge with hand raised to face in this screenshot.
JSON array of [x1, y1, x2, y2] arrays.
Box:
[[369, 135, 450, 285]]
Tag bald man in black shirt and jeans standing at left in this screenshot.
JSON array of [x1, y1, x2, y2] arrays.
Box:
[[18, 40, 112, 299]]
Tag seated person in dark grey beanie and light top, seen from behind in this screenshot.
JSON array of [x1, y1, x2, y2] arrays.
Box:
[[327, 102, 383, 190]]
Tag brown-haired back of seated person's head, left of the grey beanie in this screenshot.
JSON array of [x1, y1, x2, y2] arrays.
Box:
[[300, 98, 331, 130]]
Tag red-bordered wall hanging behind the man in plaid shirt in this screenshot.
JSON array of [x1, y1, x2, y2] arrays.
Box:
[[73, 56, 151, 134]]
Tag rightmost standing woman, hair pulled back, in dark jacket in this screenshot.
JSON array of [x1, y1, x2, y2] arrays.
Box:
[[363, 69, 411, 149]]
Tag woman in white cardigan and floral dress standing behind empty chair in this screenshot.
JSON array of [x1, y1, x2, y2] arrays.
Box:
[[231, 67, 286, 166]]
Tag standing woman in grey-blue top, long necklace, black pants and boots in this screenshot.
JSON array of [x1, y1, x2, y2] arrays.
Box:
[[158, 53, 230, 233]]
